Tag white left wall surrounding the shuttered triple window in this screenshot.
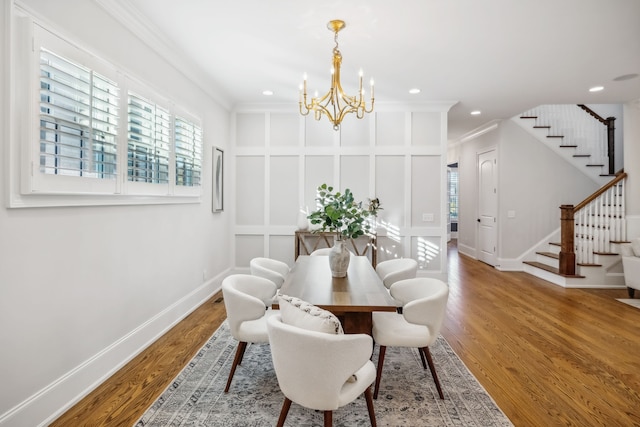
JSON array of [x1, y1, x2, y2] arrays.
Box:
[[0, 0, 232, 426]]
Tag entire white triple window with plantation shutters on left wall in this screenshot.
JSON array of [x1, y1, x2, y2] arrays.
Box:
[[15, 20, 203, 207]]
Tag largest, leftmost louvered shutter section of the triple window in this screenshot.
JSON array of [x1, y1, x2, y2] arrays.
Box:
[[40, 49, 118, 179]]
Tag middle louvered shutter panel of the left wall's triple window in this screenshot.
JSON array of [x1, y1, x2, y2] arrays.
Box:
[[127, 93, 171, 184]]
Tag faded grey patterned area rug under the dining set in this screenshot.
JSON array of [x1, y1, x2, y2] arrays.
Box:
[[135, 321, 512, 427]]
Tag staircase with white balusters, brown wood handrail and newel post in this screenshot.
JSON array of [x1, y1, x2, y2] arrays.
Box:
[[513, 105, 626, 288]]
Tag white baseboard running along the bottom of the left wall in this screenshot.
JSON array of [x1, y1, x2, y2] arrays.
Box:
[[0, 271, 228, 427]]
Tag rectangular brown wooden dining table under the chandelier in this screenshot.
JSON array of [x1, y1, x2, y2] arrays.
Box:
[[274, 255, 396, 335]]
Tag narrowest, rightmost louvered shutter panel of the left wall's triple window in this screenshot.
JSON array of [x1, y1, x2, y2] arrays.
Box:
[[175, 117, 202, 187]]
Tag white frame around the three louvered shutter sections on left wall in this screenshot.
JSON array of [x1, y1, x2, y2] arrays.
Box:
[[7, 14, 205, 208]]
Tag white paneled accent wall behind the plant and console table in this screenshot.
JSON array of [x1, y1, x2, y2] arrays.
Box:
[[231, 104, 450, 279]]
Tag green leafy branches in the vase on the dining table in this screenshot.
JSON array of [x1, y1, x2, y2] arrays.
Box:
[[307, 184, 382, 239]]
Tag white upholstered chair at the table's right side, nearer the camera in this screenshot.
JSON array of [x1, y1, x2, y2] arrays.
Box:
[[373, 278, 449, 399]]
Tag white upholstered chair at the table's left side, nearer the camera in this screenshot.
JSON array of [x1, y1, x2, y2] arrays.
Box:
[[222, 274, 277, 393]]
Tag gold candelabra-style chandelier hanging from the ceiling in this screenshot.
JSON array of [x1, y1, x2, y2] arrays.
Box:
[[300, 20, 374, 130]]
